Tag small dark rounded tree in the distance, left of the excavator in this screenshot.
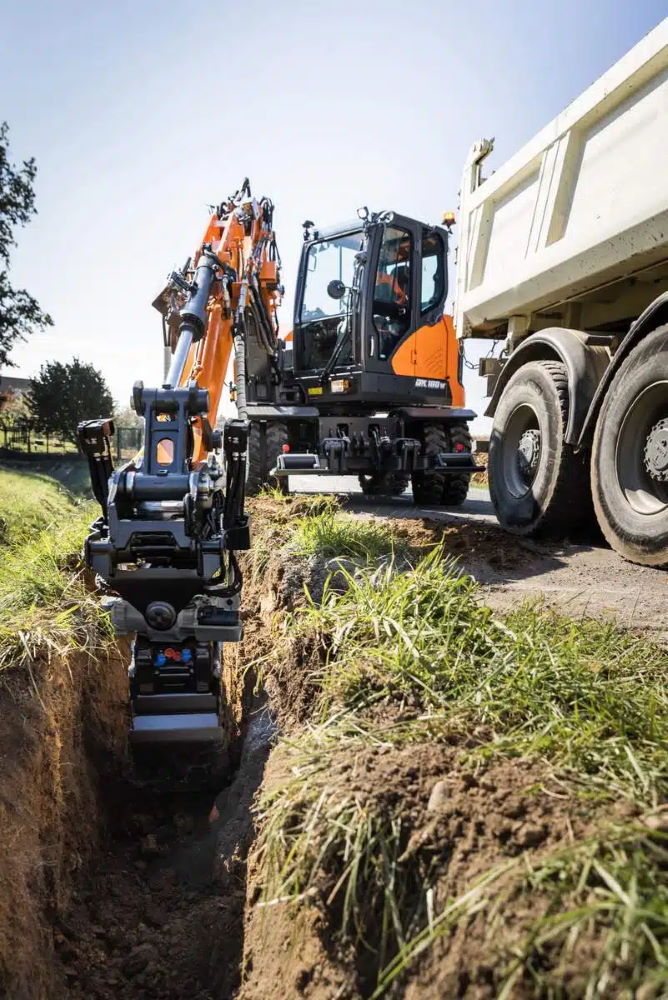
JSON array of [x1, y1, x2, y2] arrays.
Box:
[[28, 358, 114, 444]]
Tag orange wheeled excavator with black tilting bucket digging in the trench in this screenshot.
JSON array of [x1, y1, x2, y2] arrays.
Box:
[[79, 180, 476, 752]]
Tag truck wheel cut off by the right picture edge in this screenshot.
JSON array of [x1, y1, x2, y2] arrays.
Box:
[[591, 326, 668, 566]]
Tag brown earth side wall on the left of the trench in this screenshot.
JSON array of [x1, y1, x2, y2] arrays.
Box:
[[0, 655, 127, 1000]]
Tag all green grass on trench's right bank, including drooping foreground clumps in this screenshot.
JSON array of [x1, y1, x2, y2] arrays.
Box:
[[252, 536, 668, 1000]]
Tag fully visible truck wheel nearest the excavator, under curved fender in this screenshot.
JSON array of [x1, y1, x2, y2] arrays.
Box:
[[488, 361, 592, 535]]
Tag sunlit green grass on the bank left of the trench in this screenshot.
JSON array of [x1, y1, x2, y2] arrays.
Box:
[[0, 470, 110, 670]]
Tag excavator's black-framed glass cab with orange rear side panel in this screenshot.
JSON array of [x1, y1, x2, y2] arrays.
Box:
[[292, 212, 458, 406]]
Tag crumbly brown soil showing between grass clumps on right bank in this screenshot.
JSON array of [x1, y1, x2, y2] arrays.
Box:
[[240, 741, 629, 1000]]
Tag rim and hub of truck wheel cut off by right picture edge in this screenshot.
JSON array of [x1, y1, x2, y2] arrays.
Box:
[[615, 381, 668, 516]]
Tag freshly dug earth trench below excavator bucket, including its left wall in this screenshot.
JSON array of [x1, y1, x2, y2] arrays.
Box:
[[0, 564, 274, 1000]]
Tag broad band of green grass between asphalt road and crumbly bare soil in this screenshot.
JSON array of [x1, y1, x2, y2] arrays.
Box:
[[299, 549, 668, 798]]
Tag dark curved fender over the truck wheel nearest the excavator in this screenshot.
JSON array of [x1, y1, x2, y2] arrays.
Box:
[[485, 327, 610, 444]]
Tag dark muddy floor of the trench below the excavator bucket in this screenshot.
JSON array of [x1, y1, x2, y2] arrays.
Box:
[[59, 696, 275, 1000]]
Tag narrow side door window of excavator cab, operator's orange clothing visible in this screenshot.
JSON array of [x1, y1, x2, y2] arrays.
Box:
[[373, 226, 412, 360]]
